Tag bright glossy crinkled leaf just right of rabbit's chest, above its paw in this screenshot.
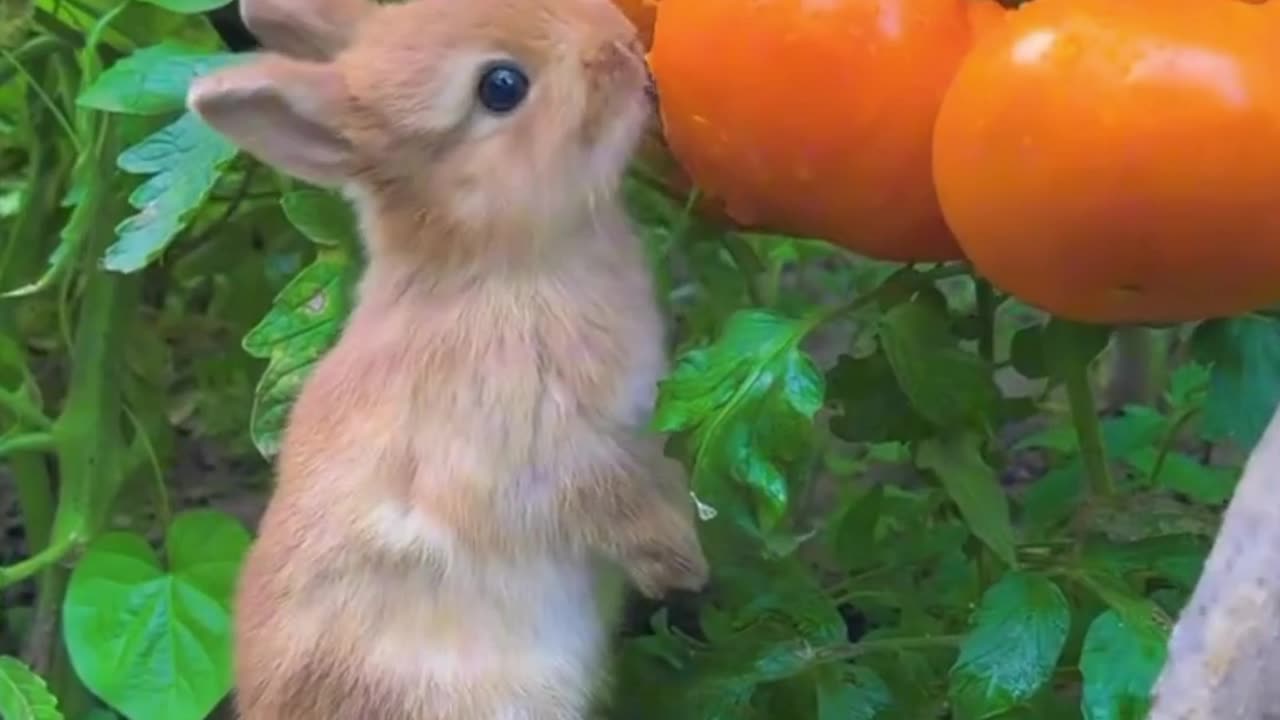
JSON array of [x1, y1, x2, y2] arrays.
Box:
[[654, 310, 826, 530]]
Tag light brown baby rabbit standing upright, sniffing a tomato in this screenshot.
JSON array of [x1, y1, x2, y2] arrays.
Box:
[[187, 0, 709, 720]]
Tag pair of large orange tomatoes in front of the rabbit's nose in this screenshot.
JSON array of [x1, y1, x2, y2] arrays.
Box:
[[634, 0, 1280, 323]]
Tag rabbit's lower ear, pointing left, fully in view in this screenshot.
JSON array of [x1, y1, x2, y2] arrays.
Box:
[[187, 56, 356, 187]]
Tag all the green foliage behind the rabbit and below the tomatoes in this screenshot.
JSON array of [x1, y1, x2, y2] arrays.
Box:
[[0, 0, 1280, 720]]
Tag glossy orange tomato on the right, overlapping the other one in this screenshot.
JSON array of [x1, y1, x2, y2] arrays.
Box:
[[934, 0, 1280, 323]]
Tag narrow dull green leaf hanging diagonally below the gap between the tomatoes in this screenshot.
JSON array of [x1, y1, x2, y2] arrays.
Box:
[[916, 433, 1018, 566]]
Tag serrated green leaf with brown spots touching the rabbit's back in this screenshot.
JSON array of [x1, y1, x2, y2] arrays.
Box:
[[242, 247, 352, 457]]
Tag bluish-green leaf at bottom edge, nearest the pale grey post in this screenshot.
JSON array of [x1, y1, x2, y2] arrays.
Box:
[[1080, 610, 1166, 720]]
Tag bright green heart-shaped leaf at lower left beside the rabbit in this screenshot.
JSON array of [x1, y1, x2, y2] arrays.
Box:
[[63, 510, 250, 720]]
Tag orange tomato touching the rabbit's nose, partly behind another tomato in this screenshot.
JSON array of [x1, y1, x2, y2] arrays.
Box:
[[649, 0, 978, 261]]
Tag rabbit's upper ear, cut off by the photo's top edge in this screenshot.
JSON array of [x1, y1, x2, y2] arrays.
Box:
[[241, 0, 378, 60]]
